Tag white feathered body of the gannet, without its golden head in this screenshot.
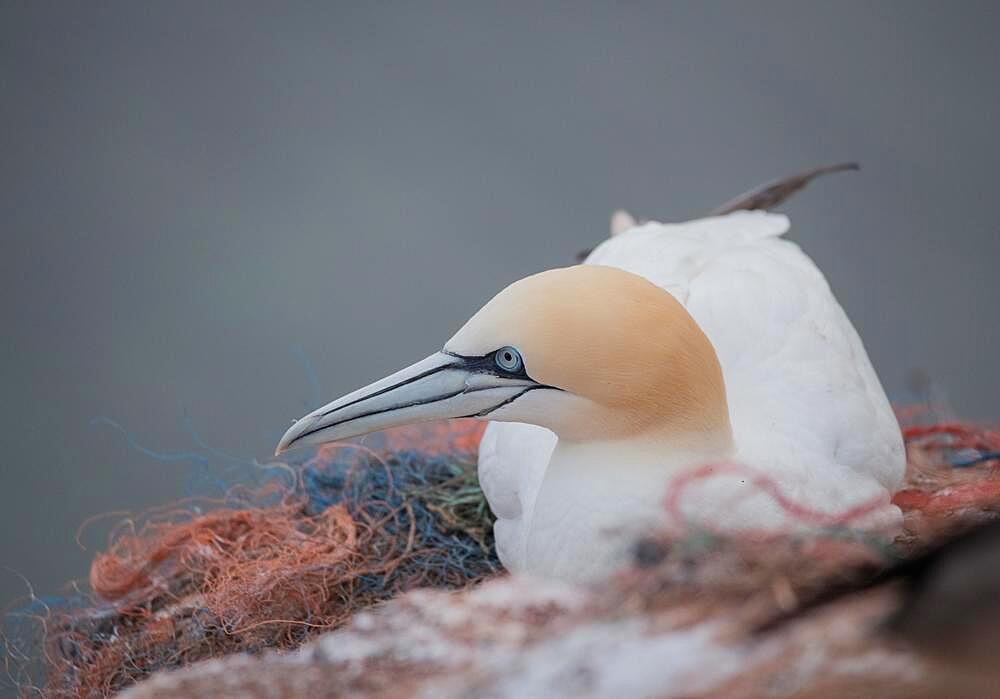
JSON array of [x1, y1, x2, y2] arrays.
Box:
[[479, 212, 905, 579]]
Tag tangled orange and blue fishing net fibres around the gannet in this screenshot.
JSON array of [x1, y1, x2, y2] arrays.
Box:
[[6, 412, 1000, 696]]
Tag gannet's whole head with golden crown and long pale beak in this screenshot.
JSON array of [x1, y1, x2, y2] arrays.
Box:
[[278, 265, 729, 453]]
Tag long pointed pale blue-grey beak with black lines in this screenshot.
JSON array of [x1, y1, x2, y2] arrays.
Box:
[[275, 352, 542, 454]]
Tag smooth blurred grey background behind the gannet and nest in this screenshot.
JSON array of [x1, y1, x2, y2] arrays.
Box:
[[0, 0, 1000, 620]]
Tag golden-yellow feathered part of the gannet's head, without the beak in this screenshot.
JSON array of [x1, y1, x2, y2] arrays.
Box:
[[445, 265, 729, 440]]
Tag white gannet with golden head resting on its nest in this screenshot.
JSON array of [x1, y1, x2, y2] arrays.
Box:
[[278, 211, 905, 581]]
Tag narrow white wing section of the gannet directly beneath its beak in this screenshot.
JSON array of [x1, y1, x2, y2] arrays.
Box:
[[479, 422, 557, 571]]
